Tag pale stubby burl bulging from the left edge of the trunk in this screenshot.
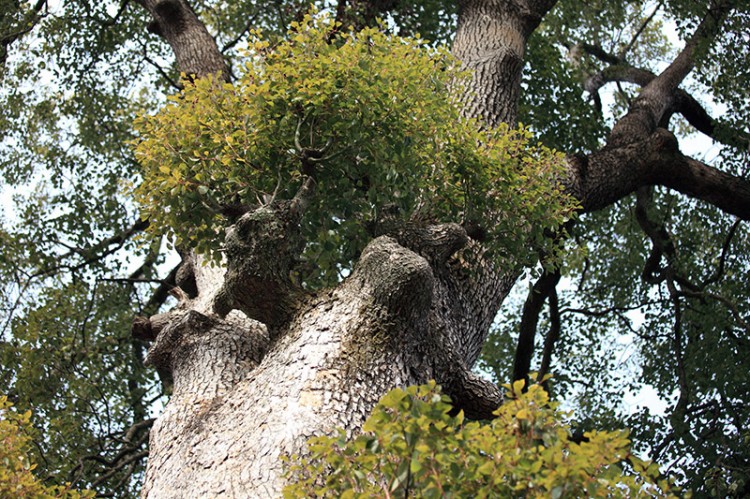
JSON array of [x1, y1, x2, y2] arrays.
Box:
[[145, 310, 269, 398]]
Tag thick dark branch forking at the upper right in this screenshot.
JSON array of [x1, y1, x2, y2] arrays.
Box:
[[566, 1, 750, 220]]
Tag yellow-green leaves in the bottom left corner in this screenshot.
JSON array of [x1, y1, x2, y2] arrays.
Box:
[[0, 396, 94, 499]]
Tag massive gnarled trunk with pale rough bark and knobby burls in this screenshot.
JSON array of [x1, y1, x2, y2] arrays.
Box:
[[138, 2, 526, 497]]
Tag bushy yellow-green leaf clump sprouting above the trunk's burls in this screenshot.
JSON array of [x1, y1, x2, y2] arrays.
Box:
[[136, 12, 572, 282]]
